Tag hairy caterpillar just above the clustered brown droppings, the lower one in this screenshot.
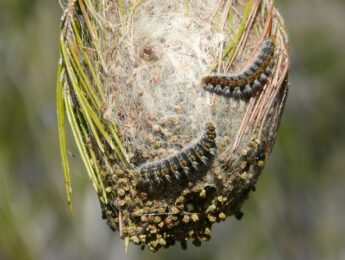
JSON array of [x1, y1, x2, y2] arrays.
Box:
[[137, 123, 217, 190]]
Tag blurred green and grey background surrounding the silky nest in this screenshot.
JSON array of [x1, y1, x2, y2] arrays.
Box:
[[0, 0, 345, 260]]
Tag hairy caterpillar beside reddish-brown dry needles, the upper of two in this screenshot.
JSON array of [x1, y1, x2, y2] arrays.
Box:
[[202, 38, 275, 98]]
